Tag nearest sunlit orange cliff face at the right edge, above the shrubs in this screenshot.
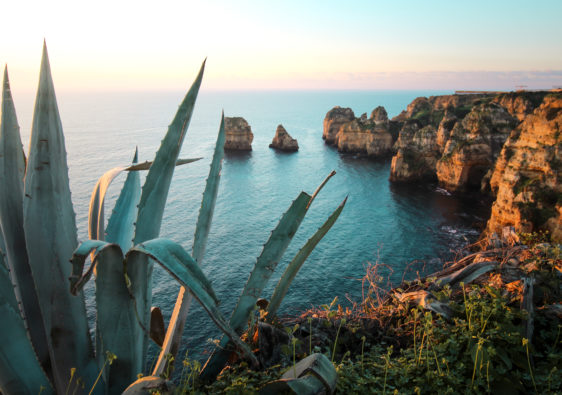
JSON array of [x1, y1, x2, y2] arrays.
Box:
[[487, 94, 562, 243]]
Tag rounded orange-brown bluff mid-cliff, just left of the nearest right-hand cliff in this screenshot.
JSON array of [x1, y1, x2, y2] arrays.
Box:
[[436, 103, 517, 191]]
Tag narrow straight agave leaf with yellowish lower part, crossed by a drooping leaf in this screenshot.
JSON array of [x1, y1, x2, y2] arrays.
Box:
[[152, 112, 226, 376]]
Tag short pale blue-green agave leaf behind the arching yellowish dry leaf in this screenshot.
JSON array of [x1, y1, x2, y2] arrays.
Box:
[[104, 149, 140, 251]]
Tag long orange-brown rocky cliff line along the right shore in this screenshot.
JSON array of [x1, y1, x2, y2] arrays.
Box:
[[322, 91, 562, 242]]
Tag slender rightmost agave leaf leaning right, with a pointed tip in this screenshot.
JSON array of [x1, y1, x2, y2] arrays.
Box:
[[267, 197, 347, 319]]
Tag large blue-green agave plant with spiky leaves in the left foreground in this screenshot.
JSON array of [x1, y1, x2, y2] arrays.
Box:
[[0, 46, 345, 394]]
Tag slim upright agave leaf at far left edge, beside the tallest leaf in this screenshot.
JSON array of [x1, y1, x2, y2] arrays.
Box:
[[0, 67, 50, 371]]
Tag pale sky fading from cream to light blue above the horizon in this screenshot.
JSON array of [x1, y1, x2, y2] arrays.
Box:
[[0, 0, 562, 91]]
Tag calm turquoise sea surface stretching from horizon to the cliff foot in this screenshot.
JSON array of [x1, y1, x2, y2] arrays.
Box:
[[13, 86, 487, 362]]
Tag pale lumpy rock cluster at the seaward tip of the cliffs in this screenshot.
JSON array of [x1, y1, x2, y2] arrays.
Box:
[[323, 106, 394, 157]]
